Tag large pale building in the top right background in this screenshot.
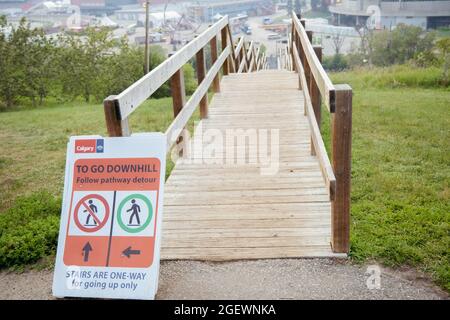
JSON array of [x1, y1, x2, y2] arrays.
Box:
[[329, 0, 450, 29]]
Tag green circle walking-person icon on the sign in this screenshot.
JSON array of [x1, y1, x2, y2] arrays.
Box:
[[117, 193, 153, 233]]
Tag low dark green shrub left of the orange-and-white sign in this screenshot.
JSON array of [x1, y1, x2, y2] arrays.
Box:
[[0, 192, 61, 268]]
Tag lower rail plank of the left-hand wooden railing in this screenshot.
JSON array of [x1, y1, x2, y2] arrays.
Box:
[[165, 47, 230, 150]]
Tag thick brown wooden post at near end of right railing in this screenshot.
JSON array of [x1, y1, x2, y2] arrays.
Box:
[[331, 84, 352, 253]]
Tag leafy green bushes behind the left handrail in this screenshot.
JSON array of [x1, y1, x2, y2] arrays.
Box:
[[0, 17, 195, 107]]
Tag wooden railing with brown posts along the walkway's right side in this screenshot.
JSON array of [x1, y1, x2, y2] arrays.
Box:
[[288, 13, 352, 253]]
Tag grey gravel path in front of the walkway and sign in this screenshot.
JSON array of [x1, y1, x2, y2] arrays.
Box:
[[0, 259, 448, 299]]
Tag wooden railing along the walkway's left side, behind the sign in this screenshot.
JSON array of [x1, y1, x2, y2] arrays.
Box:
[[104, 16, 264, 141]]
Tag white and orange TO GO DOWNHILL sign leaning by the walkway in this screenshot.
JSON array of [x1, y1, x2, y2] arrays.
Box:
[[53, 133, 166, 299]]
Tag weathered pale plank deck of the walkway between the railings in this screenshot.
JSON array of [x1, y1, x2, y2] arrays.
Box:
[[161, 69, 345, 260]]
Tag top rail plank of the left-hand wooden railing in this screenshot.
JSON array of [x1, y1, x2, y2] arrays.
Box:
[[116, 16, 228, 119]]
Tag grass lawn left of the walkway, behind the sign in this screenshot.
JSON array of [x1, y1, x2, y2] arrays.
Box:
[[0, 98, 199, 212]]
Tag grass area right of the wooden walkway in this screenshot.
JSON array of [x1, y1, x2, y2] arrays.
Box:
[[323, 70, 450, 290]]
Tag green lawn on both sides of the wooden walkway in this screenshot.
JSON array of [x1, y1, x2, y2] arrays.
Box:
[[0, 69, 450, 290]]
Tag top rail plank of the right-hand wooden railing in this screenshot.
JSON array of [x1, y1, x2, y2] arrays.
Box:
[[292, 15, 335, 113]]
